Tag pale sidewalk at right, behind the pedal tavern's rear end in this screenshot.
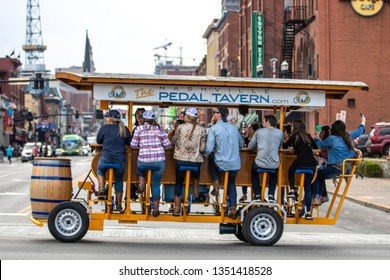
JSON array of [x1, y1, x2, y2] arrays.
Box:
[[327, 177, 390, 213]]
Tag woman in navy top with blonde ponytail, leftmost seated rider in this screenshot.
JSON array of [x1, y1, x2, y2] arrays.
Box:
[[96, 110, 131, 211]]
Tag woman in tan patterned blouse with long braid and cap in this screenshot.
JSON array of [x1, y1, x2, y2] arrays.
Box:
[[172, 108, 206, 216]]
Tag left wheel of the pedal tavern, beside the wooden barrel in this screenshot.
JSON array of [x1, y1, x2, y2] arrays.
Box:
[[47, 201, 89, 243]]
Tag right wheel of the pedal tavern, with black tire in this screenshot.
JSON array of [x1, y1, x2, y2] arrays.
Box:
[[242, 207, 284, 246]]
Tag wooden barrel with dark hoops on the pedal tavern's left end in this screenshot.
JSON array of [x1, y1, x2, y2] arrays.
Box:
[[30, 158, 72, 220]]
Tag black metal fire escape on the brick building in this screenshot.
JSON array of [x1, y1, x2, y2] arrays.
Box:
[[282, 6, 314, 78]]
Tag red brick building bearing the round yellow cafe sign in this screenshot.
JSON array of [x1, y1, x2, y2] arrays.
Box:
[[302, 0, 390, 129]]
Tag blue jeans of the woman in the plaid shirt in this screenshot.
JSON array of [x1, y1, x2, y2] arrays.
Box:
[[137, 160, 165, 200]]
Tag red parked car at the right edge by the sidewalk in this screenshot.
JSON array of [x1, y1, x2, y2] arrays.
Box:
[[367, 123, 390, 156]]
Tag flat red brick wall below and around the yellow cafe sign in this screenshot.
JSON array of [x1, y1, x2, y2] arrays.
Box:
[[316, 1, 390, 129]]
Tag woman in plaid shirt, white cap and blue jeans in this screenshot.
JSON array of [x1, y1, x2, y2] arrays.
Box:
[[130, 110, 171, 217]]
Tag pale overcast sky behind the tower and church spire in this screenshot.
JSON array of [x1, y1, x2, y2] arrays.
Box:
[[0, 0, 221, 74]]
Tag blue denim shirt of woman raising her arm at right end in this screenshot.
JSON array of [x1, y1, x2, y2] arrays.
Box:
[[314, 124, 364, 165]]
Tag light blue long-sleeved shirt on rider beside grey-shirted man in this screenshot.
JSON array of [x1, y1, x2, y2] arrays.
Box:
[[203, 120, 243, 170]]
